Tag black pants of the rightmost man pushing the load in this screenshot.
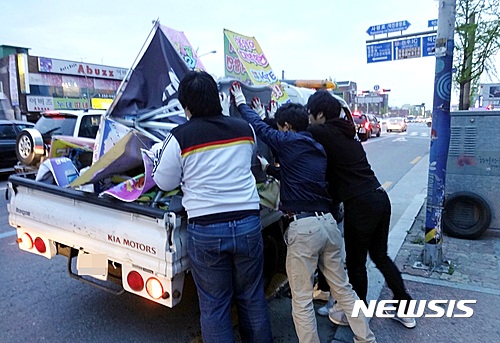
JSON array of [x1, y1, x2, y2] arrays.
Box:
[[344, 189, 411, 303]]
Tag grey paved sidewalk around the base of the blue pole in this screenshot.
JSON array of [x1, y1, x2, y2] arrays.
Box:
[[332, 201, 500, 343]]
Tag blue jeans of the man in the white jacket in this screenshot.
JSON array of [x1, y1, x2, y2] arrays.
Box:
[[187, 216, 272, 343]]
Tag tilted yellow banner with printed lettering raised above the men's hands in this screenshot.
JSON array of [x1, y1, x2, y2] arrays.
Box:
[[224, 29, 290, 104]]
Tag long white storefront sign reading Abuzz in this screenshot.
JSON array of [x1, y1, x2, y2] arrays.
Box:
[[38, 57, 127, 80]]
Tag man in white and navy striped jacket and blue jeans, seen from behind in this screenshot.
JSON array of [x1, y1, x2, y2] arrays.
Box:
[[153, 71, 272, 343]]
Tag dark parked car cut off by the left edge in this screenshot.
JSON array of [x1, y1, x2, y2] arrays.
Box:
[[0, 119, 35, 173]]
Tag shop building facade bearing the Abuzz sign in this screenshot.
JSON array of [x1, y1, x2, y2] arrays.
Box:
[[0, 45, 128, 122]]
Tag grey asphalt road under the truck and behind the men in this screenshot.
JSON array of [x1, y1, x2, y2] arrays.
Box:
[[0, 124, 428, 343]]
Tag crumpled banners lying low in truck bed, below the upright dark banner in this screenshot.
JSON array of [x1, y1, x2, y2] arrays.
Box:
[[36, 118, 279, 210]]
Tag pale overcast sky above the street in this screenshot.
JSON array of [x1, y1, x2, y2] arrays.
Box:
[[0, 0, 492, 108]]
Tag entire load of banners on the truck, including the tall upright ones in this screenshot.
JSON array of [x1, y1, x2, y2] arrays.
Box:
[[36, 21, 288, 210]]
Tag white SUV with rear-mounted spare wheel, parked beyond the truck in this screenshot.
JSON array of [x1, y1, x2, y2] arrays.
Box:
[[16, 110, 105, 166]]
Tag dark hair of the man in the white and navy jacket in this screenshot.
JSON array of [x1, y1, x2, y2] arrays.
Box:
[[178, 71, 222, 117]]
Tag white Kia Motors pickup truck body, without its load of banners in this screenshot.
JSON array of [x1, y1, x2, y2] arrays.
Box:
[[6, 174, 285, 307]]
